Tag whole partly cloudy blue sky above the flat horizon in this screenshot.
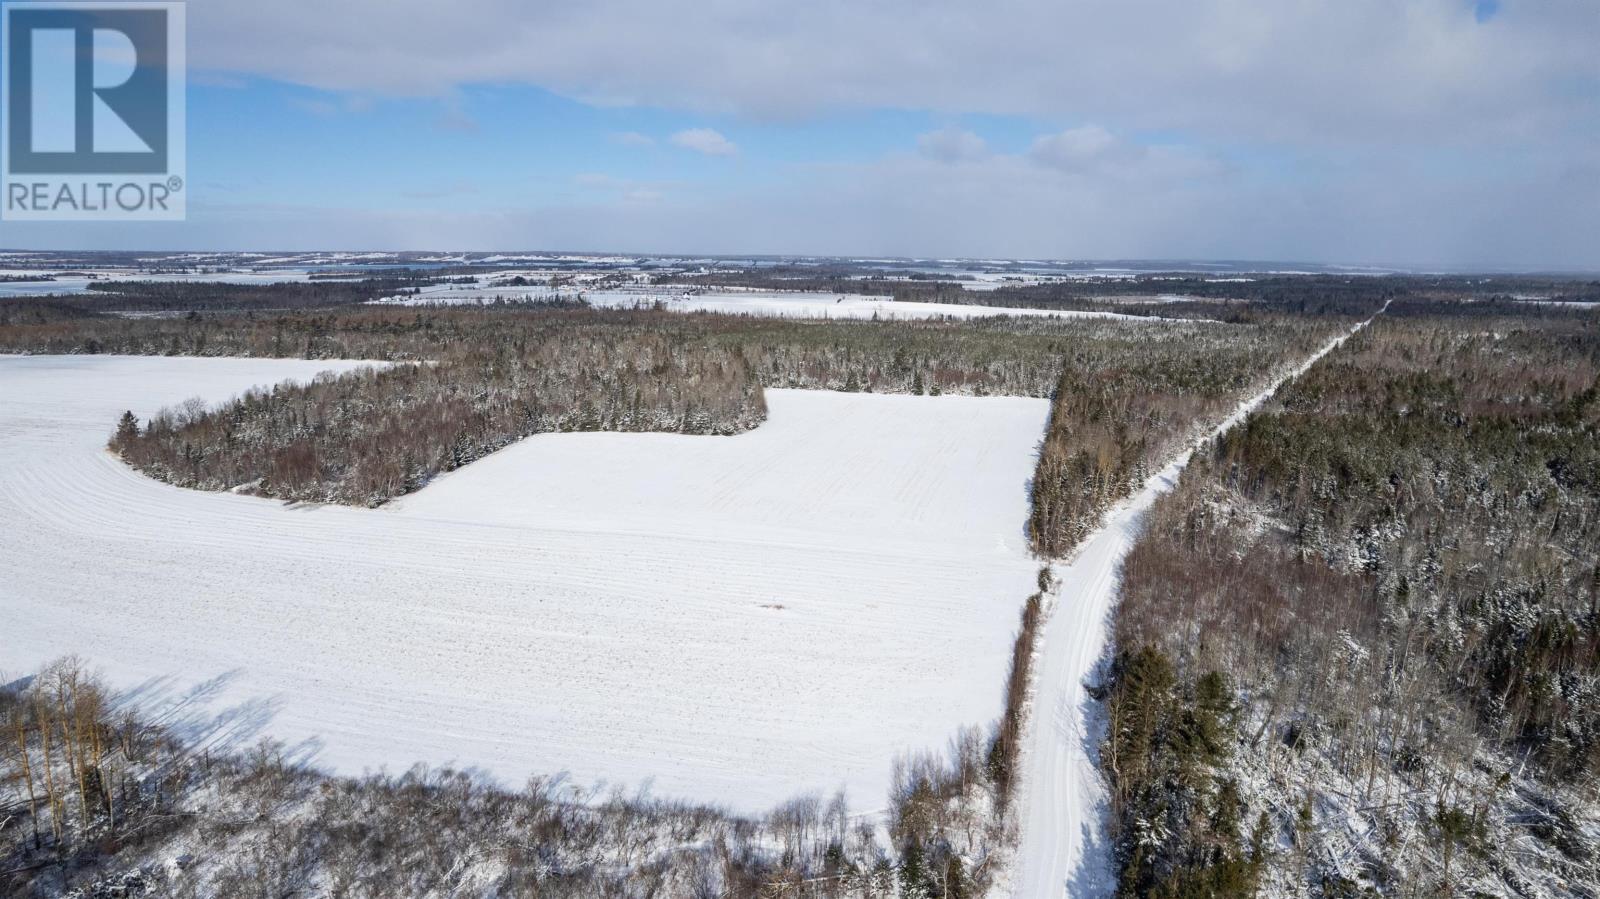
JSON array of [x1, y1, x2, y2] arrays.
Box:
[[0, 0, 1600, 270]]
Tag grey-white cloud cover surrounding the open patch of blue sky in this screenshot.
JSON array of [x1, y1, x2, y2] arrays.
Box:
[[14, 0, 1600, 267]]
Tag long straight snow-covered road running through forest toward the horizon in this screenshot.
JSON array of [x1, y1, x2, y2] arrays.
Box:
[[1014, 304, 1387, 899]]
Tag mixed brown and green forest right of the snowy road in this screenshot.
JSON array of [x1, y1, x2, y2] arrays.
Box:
[[1098, 299, 1600, 896]]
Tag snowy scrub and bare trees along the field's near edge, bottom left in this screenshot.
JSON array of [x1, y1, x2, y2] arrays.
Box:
[[0, 649, 1008, 899]]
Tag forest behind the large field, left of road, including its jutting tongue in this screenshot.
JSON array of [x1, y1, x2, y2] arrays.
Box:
[[0, 302, 1324, 524]]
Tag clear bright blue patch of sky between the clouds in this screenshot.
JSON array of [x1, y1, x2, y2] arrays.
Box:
[[189, 78, 940, 210]]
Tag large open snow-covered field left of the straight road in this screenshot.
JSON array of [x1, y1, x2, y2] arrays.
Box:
[[0, 357, 1046, 811]]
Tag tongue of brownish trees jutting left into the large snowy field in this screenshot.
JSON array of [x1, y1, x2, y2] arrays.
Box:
[[110, 330, 766, 505]]
